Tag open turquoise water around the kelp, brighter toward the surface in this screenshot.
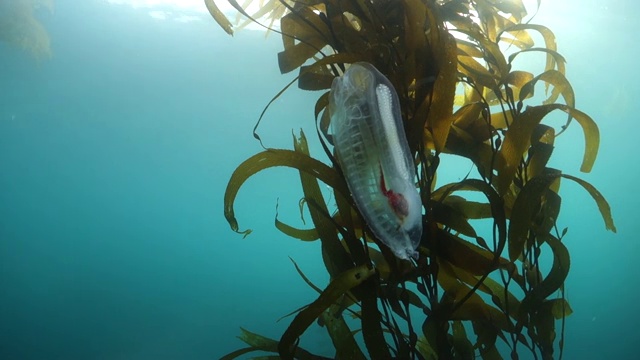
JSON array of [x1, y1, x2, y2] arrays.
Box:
[[0, 0, 640, 360]]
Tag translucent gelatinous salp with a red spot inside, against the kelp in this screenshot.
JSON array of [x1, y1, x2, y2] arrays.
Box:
[[329, 63, 422, 259]]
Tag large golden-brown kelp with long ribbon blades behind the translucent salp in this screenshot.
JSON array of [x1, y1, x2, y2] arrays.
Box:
[[210, 0, 616, 359]]
